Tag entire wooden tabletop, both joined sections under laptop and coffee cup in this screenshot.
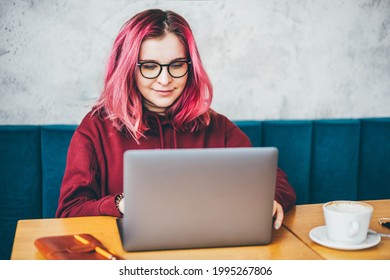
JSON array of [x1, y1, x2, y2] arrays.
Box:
[[11, 200, 390, 260]]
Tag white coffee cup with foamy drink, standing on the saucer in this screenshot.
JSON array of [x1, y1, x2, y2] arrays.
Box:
[[323, 201, 374, 244]]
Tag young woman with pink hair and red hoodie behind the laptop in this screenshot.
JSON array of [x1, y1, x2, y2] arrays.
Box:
[[56, 9, 296, 228]]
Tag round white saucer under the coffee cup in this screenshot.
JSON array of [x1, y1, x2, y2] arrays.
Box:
[[309, 226, 381, 250]]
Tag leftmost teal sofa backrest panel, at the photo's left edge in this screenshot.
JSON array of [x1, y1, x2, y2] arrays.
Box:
[[0, 126, 42, 259]]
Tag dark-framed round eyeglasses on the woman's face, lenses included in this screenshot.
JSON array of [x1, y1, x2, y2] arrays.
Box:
[[137, 60, 191, 79]]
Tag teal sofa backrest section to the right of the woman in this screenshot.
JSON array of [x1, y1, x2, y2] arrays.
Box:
[[236, 118, 390, 204]]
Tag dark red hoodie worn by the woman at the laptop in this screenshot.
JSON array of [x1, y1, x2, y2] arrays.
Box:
[[56, 111, 296, 217]]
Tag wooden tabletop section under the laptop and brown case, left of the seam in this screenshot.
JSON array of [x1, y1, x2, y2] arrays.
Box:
[[11, 216, 320, 260]]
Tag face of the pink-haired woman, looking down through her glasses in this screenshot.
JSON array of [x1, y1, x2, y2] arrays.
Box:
[[136, 33, 188, 113]]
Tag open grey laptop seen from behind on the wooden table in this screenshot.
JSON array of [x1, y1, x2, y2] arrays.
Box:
[[118, 147, 278, 252]]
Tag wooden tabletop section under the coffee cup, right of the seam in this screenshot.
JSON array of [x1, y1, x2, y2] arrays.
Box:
[[283, 200, 390, 260]]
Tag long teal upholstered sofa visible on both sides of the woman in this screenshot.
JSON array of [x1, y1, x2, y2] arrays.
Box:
[[0, 117, 390, 259]]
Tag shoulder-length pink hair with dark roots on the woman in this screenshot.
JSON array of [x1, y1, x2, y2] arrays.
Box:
[[94, 9, 213, 142]]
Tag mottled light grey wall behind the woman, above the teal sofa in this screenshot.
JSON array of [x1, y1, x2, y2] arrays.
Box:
[[0, 0, 390, 124]]
